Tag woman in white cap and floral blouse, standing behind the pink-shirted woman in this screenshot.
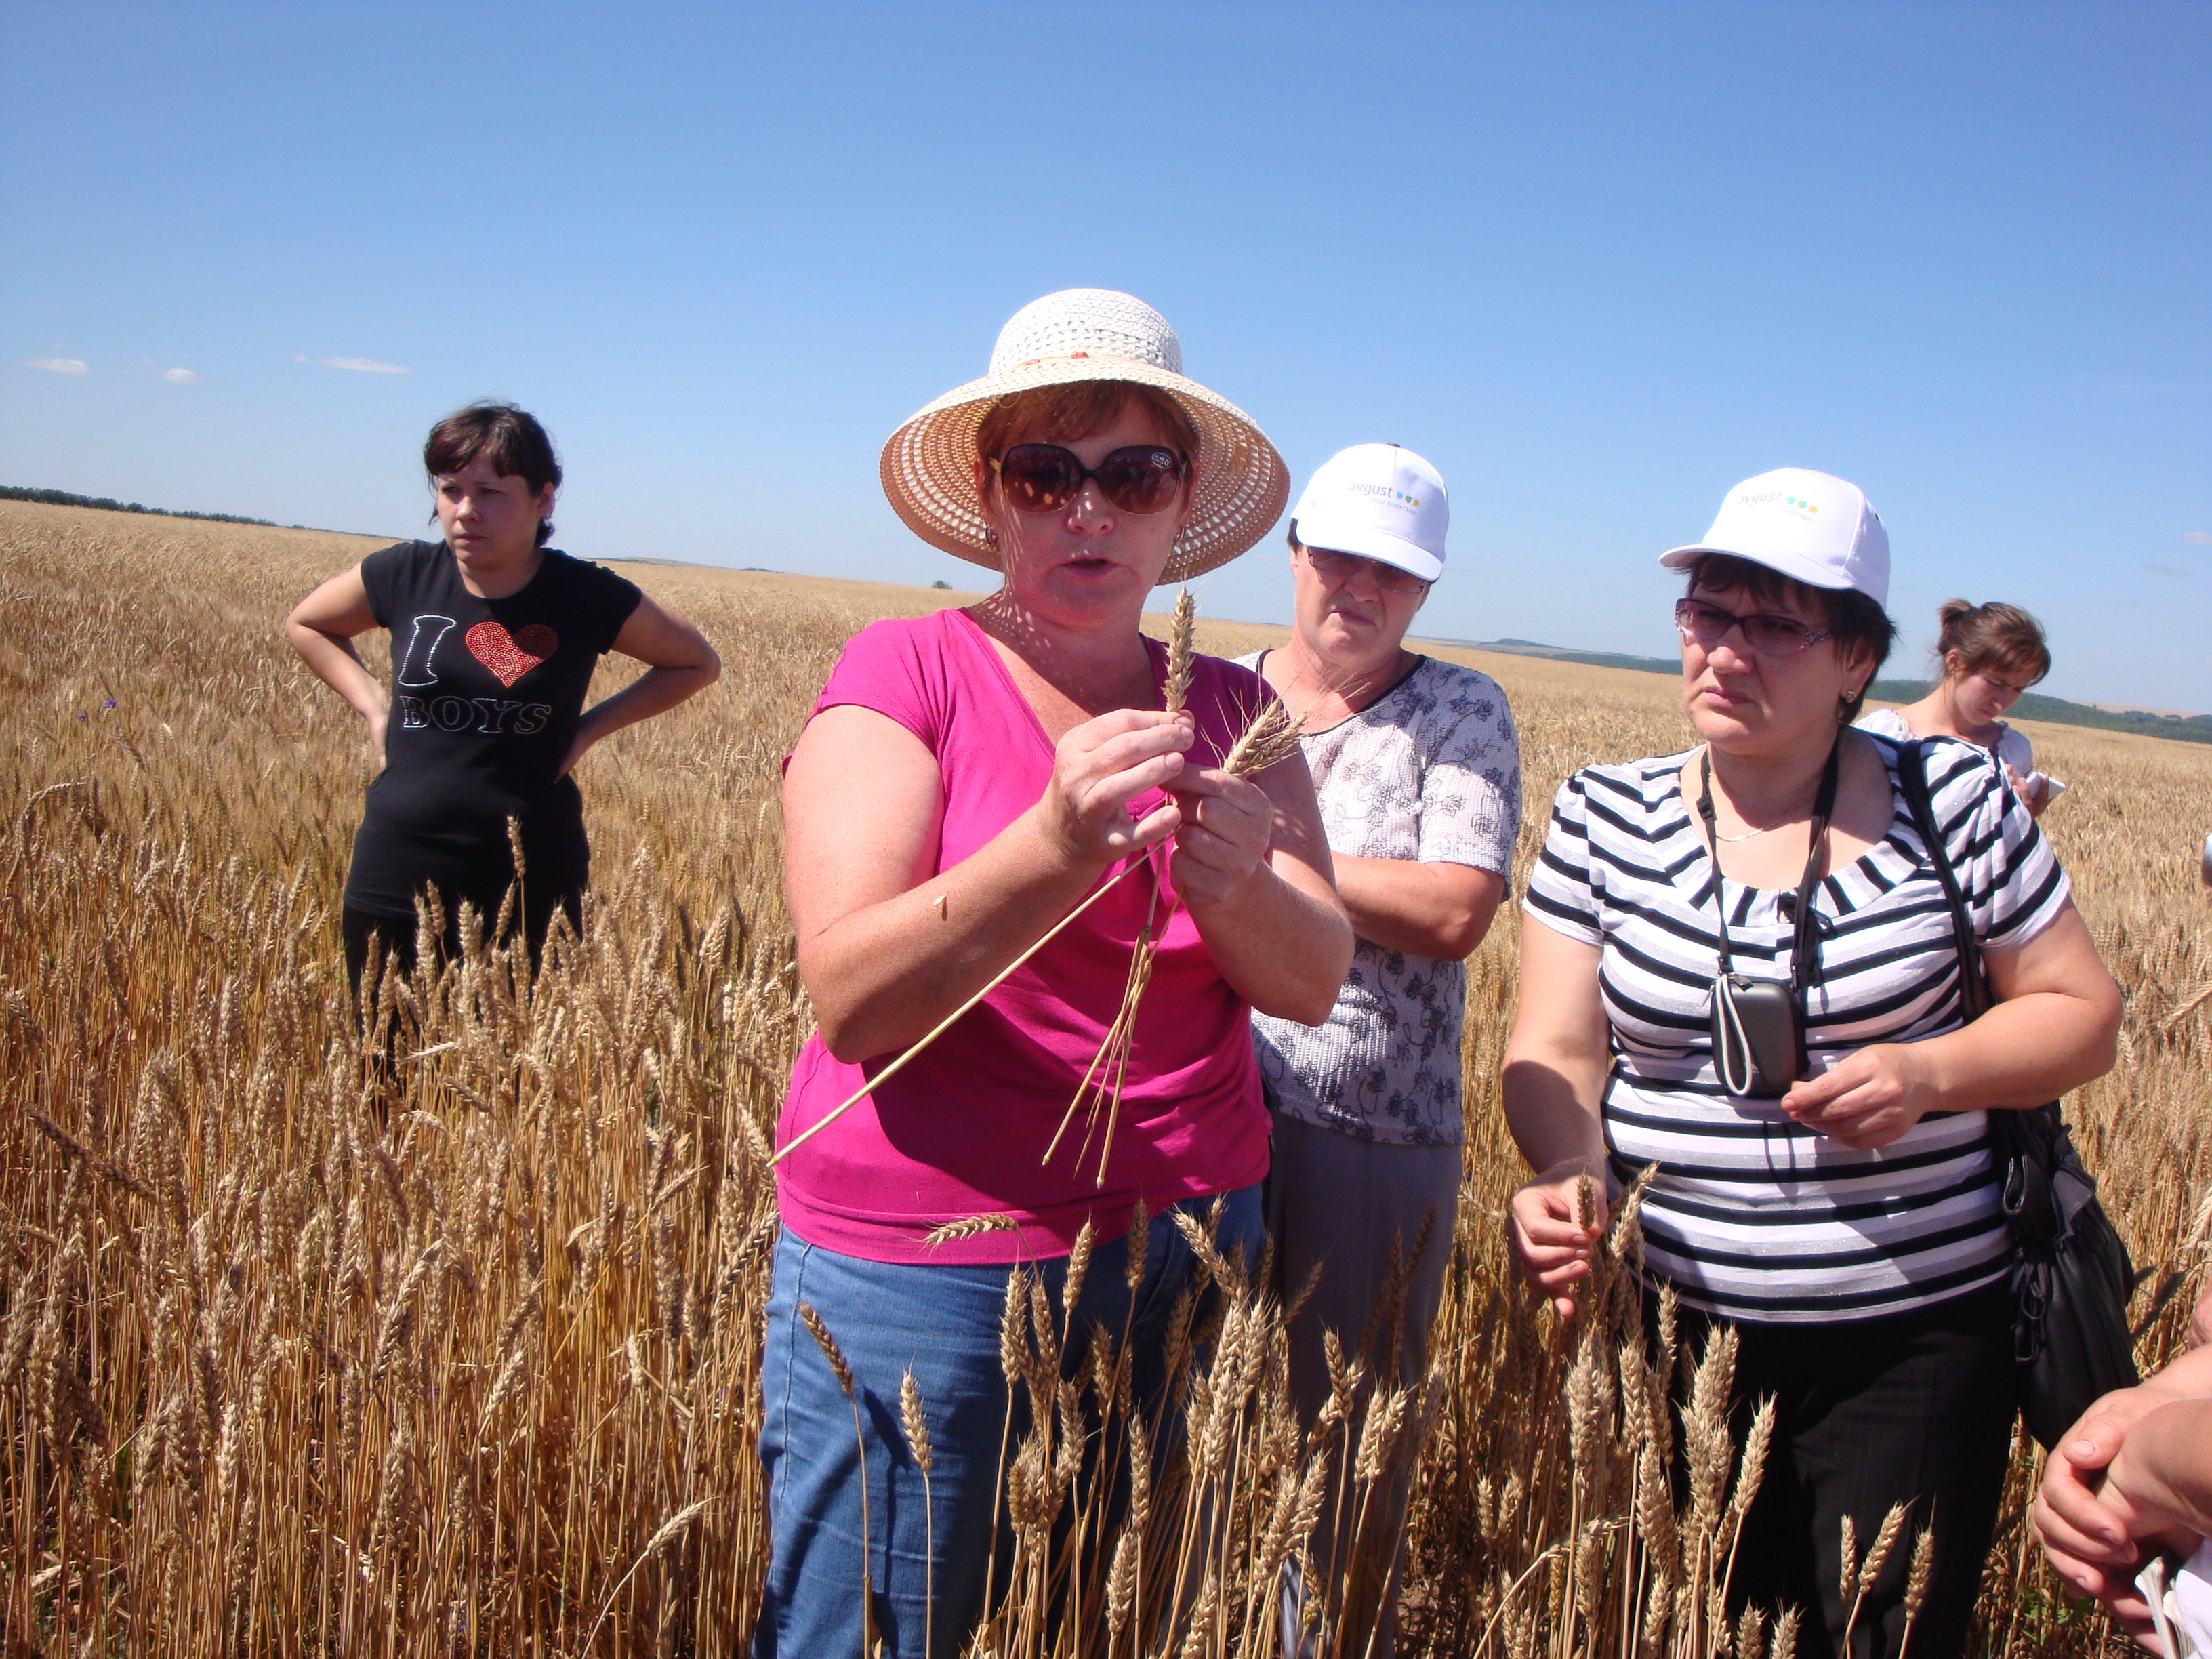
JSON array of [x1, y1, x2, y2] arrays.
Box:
[[1241, 445, 1519, 1654]]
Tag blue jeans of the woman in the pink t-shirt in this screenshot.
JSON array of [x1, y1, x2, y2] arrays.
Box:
[[752, 1186, 1263, 1659]]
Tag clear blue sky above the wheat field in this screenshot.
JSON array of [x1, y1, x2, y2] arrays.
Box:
[[0, 0, 2212, 710]]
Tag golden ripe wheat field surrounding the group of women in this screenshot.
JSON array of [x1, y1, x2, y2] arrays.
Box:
[[13, 502, 2212, 1659]]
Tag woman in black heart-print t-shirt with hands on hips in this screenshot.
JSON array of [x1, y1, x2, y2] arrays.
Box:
[[285, 403, 721, 987]]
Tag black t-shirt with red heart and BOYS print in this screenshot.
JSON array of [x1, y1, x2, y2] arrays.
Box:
[[345, 542, 642, 920]]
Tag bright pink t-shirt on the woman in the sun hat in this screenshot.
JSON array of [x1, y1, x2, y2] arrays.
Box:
[[777, 611, 1270, 1263]]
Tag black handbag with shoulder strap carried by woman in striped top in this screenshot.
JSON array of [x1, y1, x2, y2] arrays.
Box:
[[1898, 741, 2142, 1451]]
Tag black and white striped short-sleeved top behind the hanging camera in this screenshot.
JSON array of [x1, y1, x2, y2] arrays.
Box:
[[1524, 735, 2068, 1323]]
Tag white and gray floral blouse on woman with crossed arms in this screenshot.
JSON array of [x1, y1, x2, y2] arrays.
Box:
[[1239, 653, 1519, 1146]]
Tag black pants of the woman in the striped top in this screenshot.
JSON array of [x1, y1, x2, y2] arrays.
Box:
[[1681, 1283, 2020, 1659]]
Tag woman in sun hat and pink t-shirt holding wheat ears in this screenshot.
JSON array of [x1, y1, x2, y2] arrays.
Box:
[[754, 290, 1351, 1659]]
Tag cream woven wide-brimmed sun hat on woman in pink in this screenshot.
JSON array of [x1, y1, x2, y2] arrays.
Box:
[[882, 287, 1290, 581]]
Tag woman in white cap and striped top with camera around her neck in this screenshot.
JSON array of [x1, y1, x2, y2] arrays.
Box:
[[1504, 469, 2119, 1659]]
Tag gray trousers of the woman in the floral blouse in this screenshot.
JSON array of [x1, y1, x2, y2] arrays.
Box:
[[1263, 1113, 1460, 1659]]
